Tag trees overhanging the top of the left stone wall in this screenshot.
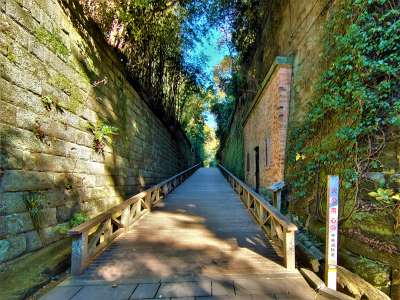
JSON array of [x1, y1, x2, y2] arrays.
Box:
[[80, 0, 206, 124]]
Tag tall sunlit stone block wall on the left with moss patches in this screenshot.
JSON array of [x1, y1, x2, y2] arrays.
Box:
[[0, 0, 194, 263]]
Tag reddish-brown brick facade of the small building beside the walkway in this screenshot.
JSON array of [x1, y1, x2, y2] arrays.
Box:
[[244, 62, 292, 187]]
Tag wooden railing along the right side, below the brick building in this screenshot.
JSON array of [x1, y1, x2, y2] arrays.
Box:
[[218, 165, 297, 270]]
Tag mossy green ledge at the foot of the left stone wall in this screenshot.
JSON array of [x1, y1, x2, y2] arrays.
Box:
[[0, 239, 71, 299]]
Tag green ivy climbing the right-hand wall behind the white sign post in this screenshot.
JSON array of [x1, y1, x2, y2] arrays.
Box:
[[287, 0, 400, 223]]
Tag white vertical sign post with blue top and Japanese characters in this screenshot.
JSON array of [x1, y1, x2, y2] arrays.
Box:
[[325, 175, 339, 290]]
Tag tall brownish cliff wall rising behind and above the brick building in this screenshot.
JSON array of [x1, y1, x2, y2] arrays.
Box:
[[221, 0, 330, 183]]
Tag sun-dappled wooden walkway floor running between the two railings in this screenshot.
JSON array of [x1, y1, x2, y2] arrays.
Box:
[[44, 168, 315, 300]]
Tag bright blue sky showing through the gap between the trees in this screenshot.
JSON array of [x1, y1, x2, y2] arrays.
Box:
[[185, 27, 229, 128]]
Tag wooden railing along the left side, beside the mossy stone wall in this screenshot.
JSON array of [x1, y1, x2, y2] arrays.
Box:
[[69, 164, 200, 275]]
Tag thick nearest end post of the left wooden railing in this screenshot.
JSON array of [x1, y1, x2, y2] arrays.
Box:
[[71, 231, 88, 275]]
